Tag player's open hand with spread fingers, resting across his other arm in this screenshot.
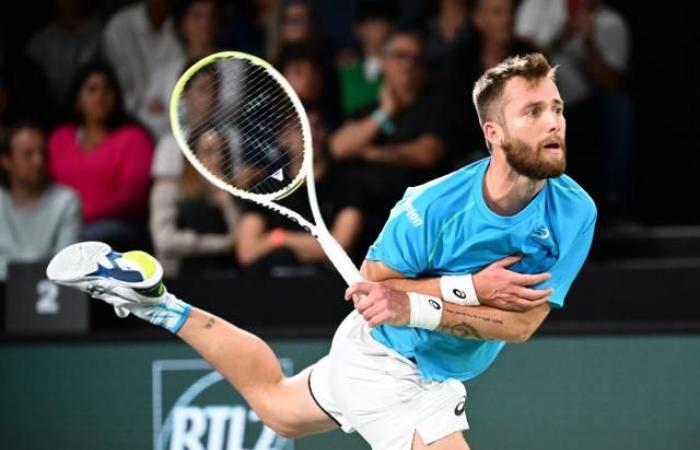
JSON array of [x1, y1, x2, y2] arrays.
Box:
[[472, 256, 553, 311]]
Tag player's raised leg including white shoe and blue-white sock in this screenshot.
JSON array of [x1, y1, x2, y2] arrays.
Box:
[[46, 241, 336, 437]]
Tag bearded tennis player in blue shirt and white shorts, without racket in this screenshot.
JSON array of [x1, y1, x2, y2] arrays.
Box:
[[47, 54, 596, 450]]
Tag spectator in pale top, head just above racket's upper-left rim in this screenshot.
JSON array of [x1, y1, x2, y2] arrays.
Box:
[[138, 0, 219, 140]]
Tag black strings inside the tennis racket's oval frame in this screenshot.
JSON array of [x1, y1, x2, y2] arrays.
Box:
[[178, 60, 305, 194]]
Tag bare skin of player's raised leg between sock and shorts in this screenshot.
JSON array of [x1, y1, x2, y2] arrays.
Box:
[[177, 308, 337, 438]]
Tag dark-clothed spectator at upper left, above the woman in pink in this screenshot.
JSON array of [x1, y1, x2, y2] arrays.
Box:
[[27, 0, 102, 111]]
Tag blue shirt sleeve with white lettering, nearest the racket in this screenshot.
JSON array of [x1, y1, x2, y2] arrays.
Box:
[[367, 189, 431, 278]]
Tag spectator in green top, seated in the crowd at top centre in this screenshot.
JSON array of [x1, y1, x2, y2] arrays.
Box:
[[339, 0, 393, 117]]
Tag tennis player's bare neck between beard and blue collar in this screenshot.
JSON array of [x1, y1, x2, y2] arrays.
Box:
[[483, 152, 545, 216]]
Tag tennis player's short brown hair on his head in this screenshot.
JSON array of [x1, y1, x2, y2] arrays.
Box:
[[472, 53, 557, 126]]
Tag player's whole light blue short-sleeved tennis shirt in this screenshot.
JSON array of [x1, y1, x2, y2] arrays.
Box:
[[367, 158, 596, 381]]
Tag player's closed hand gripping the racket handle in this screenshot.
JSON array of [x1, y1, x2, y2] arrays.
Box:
[[345, 281, 411, 327]]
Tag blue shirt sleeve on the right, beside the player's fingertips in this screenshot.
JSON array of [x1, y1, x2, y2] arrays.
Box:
[[537, 218, 595, 308]]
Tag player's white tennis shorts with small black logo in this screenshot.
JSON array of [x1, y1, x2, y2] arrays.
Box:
[[309, 311, 469, 450]]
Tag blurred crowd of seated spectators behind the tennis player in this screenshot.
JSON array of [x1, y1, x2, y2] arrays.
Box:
[[0, 0, 635, 281]]
